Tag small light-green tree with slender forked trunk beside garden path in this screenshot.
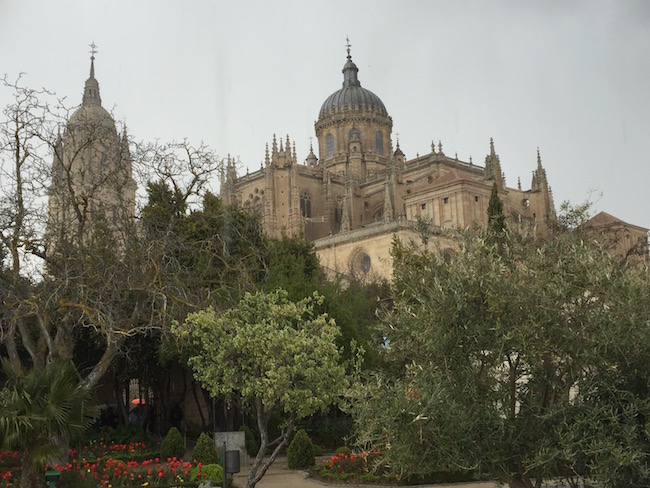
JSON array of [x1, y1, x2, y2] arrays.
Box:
[[172, 290, 346, 488]]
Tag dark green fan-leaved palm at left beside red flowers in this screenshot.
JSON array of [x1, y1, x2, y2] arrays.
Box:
[[0, 360, 97, 486]]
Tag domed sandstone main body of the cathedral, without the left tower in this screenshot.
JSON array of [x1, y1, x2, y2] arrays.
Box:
[[221, 46, 555, 276]]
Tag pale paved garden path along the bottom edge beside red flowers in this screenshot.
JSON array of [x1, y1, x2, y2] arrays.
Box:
[[233, 457, 497, 488]]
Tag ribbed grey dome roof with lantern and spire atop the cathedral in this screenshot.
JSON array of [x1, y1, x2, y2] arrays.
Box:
[[318, 46, 388, 119]]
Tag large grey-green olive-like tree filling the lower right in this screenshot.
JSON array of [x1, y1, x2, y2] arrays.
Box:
[[354, 233, 650, 488]]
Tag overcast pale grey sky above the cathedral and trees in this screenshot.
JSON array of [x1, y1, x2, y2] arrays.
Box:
[[0, 0, 650, 227]]
